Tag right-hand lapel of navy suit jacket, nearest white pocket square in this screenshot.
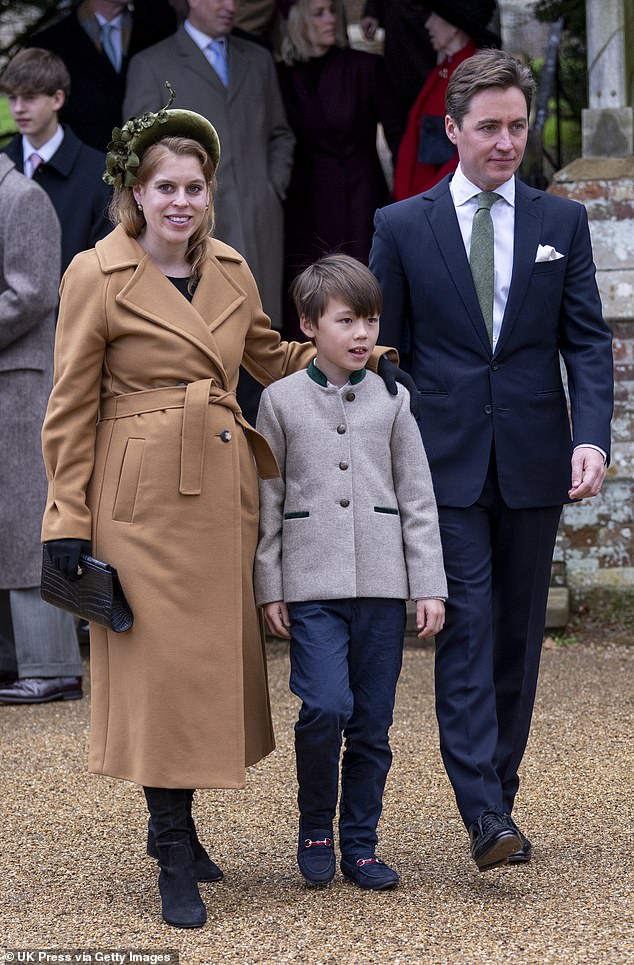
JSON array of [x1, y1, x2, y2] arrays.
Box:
[[496, 179, 542, 352]]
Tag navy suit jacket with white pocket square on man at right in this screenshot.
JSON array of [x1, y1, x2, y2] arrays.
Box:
[[370, 176, 613, 509]]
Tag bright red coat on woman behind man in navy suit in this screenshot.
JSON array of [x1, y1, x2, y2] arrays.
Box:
[[394, 40, 477, 201]]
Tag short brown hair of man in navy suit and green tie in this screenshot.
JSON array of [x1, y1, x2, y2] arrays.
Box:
[[445, 50, 535, 130]]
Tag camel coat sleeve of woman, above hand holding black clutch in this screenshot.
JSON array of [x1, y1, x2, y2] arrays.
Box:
[[42, 250, 107, 540]]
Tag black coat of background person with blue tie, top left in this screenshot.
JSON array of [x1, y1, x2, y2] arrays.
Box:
[[29, 0, 177, 152]]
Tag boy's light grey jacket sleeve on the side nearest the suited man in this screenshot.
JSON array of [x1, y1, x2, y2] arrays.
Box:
[[390, 387, 447, 600]]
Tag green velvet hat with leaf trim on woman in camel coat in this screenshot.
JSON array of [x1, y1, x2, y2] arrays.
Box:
[[103, 81, 220, 188]]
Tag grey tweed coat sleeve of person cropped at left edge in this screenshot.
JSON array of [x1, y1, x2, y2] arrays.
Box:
[[0, 178, 61, 351]]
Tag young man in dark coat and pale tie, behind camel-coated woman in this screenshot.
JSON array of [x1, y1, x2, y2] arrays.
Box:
[[0, 47, 112, 273]]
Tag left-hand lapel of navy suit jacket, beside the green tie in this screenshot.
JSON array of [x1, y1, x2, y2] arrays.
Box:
[[423, 178, 491, 354]]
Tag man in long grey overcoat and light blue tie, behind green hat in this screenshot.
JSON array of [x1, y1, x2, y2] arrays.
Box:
[[123, 0, 295, 328]]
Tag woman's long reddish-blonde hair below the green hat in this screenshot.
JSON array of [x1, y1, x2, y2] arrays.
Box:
[[108, 137, 216, 293]]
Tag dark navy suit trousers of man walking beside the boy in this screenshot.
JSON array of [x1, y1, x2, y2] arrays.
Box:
[[435, 455, 561, 827]]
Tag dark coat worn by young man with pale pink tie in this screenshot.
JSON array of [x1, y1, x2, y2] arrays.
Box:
[[2, 127, 112, 273]]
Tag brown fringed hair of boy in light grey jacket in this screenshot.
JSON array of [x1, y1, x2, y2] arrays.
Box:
[[291, 255, 383, 327]]
